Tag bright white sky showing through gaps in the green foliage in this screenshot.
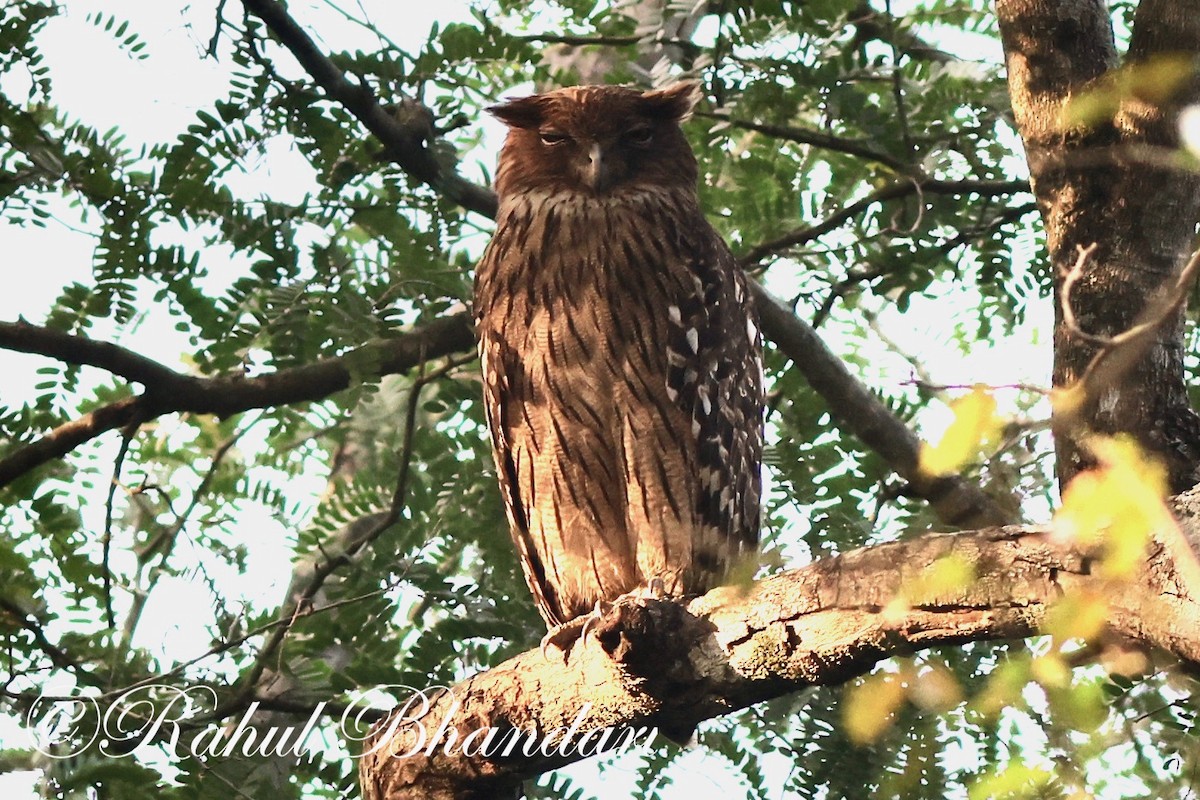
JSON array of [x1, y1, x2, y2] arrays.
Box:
[[0, 0, 1049, 799]]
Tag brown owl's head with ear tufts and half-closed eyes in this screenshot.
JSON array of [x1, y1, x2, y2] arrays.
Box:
[[487, 82, 700, 199]]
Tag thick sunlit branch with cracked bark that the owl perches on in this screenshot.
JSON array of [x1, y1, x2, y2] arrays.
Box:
[[360, 528, 1200, 800]]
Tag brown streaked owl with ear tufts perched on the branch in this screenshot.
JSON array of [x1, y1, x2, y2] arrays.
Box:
[[475, 83, 763, 642]]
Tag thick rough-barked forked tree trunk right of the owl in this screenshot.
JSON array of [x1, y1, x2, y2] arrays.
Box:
[[996, 0, 1200, 492]]
